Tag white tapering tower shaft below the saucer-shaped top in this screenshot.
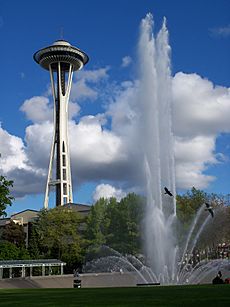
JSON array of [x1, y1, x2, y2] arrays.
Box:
[[44, 62, 73, 208]]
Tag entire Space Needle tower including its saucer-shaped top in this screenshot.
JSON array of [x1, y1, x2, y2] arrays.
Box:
[[34, 40, 89, 209]]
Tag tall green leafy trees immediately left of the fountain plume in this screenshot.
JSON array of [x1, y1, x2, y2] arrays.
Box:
[[86, 193, 144, 254]]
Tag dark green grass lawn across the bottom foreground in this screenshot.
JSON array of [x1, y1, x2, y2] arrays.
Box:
[[0, 285, 230, 307]]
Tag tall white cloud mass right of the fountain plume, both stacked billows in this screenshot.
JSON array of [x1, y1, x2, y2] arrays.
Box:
[[172, 72, 230, 189]]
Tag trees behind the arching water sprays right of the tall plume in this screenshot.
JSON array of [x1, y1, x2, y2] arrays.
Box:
[[177, 188, 230, 253]]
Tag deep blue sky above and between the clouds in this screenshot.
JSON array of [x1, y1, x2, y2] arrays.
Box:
[[0, 0, 230, 213]]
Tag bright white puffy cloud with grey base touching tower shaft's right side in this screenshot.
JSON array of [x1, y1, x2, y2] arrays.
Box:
[[69, 116, 127, 181]]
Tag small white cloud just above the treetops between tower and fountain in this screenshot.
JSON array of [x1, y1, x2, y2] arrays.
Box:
[[93, 183, 126, 201]]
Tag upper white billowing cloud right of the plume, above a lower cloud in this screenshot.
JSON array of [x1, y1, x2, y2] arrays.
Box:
[[172, 72, 230, 136]]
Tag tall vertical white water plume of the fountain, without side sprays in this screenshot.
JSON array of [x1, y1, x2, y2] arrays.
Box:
[[138, 14, 176, 280]]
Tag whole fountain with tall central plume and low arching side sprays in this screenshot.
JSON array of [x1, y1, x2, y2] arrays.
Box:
[[82, 14, 229, 284]]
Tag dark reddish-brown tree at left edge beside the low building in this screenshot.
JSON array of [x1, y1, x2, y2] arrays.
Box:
[[2, 221, 26, 247]]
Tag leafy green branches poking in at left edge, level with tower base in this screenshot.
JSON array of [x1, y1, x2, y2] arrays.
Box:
[[0, 176, 14, 217]]
